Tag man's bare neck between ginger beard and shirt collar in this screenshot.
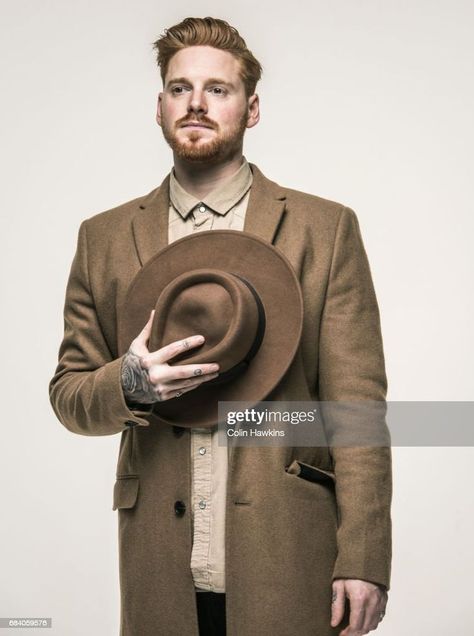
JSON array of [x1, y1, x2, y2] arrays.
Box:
[[174, 149, 242, 199]]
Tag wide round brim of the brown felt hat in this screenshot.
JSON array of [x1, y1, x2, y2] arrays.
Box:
[[117, 230, 303, 427]]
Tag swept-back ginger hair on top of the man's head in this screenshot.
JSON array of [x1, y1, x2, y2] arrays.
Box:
[[153, 17, 262, 97]]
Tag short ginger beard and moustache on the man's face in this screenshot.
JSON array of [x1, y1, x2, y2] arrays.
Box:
[[161, 111, 248, 163]]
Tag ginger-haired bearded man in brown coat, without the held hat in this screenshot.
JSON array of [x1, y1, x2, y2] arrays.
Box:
[[50, 18, 391, 636]]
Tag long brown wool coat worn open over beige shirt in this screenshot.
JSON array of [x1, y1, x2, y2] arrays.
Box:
[[49, 164, 392, 636]]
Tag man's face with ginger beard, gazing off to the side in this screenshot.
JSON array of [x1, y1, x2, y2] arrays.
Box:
[[156, 46, 259, 163]]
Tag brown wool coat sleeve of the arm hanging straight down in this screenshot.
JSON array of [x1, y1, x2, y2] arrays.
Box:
[[318, 208, 392, 589]]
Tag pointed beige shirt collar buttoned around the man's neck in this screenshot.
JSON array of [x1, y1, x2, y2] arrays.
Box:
[[170, 157, 253, 219]]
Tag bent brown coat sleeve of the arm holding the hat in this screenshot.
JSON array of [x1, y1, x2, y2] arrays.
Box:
[[49, 221, 151, 435]]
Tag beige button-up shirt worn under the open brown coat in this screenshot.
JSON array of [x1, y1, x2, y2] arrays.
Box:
[[168, 157, 252, 592]]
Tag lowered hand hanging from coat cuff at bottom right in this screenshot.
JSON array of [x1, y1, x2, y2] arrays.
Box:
[[331, 579, 388, 636]]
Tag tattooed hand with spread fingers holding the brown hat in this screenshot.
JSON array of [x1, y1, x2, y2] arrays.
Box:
[[122, 310, 219, 404]]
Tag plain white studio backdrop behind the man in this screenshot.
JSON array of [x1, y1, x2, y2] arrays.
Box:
[[0, 0, 474, 636]]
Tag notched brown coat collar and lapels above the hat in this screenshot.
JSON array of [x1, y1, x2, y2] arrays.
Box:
[[132, 163, 286, 266]]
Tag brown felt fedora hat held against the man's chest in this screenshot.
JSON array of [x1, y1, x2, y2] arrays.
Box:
[[117, 230, 303, 427]]
